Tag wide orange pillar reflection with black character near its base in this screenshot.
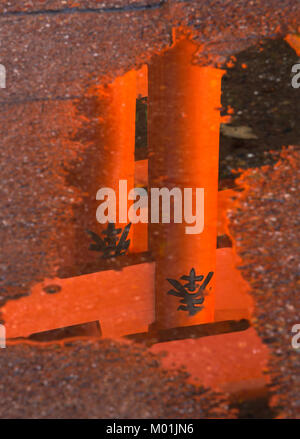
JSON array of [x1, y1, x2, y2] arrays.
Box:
[[148, 40, 224, 328]]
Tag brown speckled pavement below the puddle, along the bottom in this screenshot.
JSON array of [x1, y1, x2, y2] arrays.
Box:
[[0, 340, 234, 419]]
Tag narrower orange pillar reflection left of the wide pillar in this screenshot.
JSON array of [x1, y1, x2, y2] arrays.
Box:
[[86, 71, 136, 251]]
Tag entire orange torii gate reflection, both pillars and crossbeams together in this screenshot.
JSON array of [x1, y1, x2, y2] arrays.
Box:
[[2, 39, 251, 338]]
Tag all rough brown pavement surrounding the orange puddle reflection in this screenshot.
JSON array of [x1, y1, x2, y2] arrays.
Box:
[[0, 0, 300, 418]]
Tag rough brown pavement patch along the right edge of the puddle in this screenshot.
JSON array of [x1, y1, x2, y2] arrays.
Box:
[[230, 147, 300, 418]]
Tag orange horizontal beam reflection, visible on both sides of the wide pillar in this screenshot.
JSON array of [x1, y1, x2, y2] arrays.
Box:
[[2, 248, 253, 338]]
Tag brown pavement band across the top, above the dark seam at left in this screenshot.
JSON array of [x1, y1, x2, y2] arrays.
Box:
[[0, 0, 300, 102]]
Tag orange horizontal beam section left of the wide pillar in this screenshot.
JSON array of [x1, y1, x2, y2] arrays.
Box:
[[2, 263, 154, 338]]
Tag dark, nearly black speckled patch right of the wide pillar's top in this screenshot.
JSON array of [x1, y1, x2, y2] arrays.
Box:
[[220, 39, 300, 180]]
